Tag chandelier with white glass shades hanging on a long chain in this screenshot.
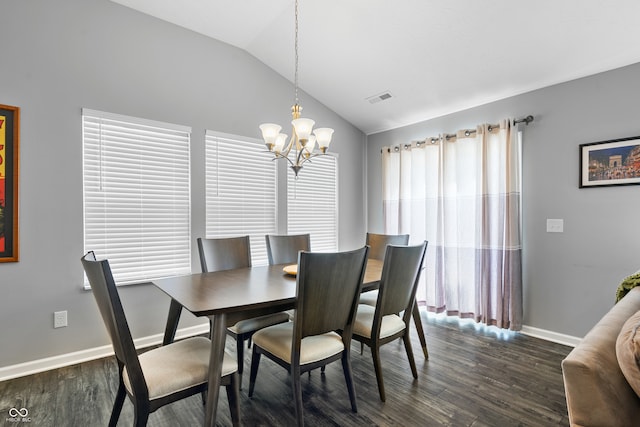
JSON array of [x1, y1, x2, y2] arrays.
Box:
[[260, 0, 333, 178]]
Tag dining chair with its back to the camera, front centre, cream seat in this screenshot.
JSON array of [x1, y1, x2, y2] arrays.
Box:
[[249, 246, 369, 426]]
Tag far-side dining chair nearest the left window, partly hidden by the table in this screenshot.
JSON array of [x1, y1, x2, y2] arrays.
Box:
[[197, 236, 289, 388]]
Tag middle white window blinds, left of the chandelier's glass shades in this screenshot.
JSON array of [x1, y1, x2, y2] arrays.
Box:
[[205, 131, 277, 265]]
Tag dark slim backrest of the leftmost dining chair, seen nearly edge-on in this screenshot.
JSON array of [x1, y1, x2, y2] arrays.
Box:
[[81, 251, 149, 399]]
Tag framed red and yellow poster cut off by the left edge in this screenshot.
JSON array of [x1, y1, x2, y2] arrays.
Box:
[[0, 105, 20, 262]]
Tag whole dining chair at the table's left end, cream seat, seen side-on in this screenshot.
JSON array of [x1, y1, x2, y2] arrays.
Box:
[[81, 252, 240, 426]]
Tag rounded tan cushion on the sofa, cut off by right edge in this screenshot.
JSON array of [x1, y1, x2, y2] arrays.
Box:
[[616, 311, 640, 396]]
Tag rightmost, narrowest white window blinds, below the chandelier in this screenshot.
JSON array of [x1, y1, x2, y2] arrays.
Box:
[[287, 155, 338, 252]]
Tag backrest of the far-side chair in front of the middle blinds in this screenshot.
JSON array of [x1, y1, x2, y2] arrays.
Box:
[[198, 236, 251, 273]]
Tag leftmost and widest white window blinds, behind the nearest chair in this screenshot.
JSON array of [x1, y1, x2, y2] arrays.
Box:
[[82, 109, 191, 284]]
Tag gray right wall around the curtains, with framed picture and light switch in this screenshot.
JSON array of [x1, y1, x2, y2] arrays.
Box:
[[367, 64, 640, 337]]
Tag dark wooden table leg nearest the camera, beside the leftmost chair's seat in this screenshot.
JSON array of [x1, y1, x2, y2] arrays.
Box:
[[204, 314, 227, 427]]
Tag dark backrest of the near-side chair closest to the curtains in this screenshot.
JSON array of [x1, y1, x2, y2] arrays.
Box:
[[374, 241, 428, 320]]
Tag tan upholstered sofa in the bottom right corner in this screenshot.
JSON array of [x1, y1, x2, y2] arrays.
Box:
[[562, 287, 640, 427]]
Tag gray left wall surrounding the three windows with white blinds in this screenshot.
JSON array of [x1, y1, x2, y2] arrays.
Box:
[[0, 0, 366, 367]]
